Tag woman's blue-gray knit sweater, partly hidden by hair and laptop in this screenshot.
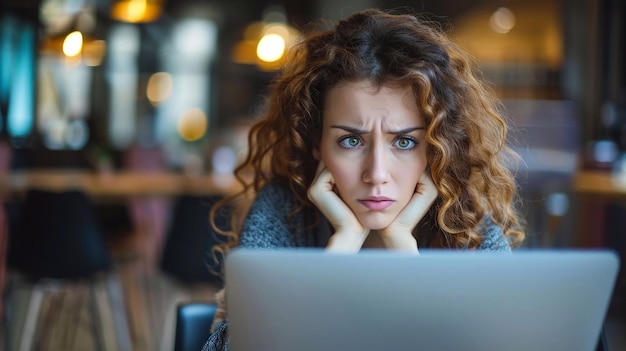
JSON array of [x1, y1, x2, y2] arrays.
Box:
[[202, 181, 511, 351]]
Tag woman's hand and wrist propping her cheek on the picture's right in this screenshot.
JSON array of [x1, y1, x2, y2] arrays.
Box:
[[380, 171, 439, 252]]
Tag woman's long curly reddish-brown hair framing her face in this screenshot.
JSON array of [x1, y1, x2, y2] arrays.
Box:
[[210, 9, 524, 258]]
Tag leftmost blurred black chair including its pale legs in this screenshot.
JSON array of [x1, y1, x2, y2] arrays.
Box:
[[7, 189, 131, 350]]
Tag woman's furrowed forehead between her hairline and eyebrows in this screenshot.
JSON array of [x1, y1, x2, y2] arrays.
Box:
[[322, 81, 423, 127]]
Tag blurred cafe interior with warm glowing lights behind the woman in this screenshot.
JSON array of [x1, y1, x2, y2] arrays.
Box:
[[0, 0, 626, 351]]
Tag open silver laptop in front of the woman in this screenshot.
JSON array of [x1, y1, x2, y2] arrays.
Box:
[[225, 249, 619, 351]]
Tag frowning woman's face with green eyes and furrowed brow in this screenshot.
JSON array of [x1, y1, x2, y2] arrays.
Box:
[[319, 81, 427, 230]]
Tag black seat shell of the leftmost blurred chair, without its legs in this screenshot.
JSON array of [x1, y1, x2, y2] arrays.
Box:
[[7, 189, 111, 279]]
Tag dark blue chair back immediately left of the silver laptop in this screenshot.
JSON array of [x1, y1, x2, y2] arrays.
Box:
[[174, 302, 217, 351]]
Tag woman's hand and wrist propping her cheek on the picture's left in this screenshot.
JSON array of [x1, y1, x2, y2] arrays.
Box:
[[308, 161, 369, 252]]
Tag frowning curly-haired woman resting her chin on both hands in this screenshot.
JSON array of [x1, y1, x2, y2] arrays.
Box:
[[205, 9, 524, 350]]
